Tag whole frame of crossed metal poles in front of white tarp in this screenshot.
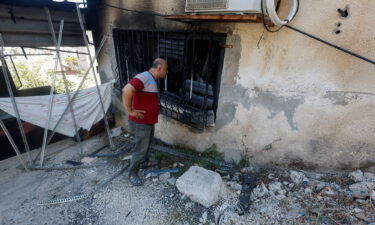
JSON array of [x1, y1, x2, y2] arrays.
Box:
[[0, 5, 115, 171]]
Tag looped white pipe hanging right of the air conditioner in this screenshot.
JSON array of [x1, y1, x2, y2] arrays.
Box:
[[265, 0, 298, 27]]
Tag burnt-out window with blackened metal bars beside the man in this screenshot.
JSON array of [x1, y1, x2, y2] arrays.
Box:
[[113, 29, 226, 129]]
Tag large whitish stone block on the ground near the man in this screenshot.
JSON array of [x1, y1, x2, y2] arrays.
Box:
[[176, 166, 224, 208]]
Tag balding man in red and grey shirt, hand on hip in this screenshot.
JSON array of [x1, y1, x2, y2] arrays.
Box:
[[122, 58, 168, 186]]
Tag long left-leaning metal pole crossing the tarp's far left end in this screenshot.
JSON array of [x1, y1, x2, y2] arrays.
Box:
[[0, 34, 32, 166]]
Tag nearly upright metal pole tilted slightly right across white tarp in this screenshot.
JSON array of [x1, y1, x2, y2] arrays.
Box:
[[40, 20, 64, 166]]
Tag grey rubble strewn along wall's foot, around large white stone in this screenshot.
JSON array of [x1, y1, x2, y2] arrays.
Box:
[[150, 163, 375, 225]]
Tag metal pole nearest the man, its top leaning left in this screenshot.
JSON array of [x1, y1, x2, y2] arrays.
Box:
[[76, 4, 115, 150]]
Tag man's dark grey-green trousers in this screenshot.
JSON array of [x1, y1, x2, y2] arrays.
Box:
[[129, 120, 155, 173]]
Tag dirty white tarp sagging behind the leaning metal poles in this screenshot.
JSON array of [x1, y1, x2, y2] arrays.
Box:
[[0, 82, 113, 137]]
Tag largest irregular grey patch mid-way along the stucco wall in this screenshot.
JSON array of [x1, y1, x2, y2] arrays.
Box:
[[252, 87, 304, 130]]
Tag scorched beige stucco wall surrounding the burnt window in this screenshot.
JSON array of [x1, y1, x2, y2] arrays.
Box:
[[96, 0, 375, 169]]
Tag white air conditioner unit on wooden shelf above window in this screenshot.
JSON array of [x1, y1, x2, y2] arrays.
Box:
[[185, 0, 261, 14]]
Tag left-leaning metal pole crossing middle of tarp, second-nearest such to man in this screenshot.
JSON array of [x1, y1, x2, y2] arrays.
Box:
[[44, 8, 83, 157]]
